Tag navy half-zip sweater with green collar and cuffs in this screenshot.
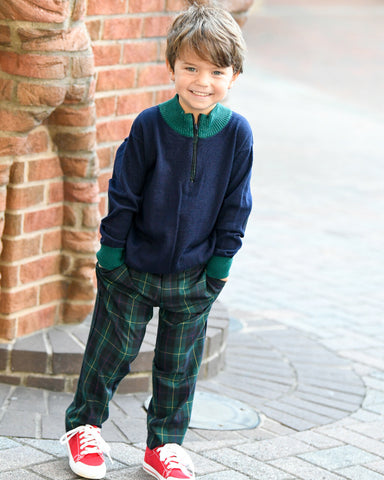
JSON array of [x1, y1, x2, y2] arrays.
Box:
[[97, 96, 253, 278]]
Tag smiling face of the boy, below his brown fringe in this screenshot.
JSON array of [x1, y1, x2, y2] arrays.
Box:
[[166, 48, 239, 121]]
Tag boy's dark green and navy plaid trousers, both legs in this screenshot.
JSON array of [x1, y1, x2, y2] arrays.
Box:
[[66, 265, 224, 449]]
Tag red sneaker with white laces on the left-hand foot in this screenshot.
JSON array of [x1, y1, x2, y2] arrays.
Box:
[[60, 425, 111, 479]]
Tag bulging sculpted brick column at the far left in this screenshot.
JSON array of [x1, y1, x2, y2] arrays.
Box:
[[0, 0, 99, 339]]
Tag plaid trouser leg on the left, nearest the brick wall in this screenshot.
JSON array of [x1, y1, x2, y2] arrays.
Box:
[[66, 265, 153, 431]]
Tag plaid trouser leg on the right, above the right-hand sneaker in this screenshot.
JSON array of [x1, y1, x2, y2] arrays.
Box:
[[147, 268, 224, 449]]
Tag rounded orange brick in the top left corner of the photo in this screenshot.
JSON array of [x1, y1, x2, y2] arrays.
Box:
[[0, 0, 70, 23]]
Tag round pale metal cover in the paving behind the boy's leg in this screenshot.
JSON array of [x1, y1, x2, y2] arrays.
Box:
[[144, 392, 260, 430]]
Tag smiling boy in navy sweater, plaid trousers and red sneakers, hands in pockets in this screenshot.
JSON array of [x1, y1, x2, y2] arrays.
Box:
[[62, 5, 253, 480]]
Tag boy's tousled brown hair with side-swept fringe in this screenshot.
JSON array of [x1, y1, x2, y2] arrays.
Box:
[[166, 2, 245, 73]]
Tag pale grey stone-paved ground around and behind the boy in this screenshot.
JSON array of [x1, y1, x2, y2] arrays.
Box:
[[0, 0, 384, 480]]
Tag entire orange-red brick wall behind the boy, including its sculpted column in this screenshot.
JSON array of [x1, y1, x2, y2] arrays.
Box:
[[0, 0, 253, 340]]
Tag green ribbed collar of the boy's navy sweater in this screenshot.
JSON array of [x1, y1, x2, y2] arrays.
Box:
[[159, 95, 232, 138]]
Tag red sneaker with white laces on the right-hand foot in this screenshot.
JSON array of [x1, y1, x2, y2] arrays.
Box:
[[143, 443, 195, 480]]
